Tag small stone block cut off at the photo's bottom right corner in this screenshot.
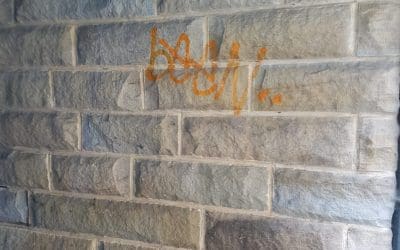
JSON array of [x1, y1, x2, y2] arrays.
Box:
[[347, 228, 392, 250]]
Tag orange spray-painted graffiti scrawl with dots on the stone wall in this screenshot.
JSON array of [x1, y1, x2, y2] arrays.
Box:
[[145, 27, 282, 115]]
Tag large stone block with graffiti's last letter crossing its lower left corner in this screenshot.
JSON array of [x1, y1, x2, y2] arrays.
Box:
[[209, 5, 353, 60]]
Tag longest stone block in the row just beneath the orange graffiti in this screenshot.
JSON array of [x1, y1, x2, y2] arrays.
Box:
[[182, 116, 355, 168]]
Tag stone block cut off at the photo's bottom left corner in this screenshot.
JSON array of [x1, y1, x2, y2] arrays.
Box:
[[0, 227, 93, 250]]
